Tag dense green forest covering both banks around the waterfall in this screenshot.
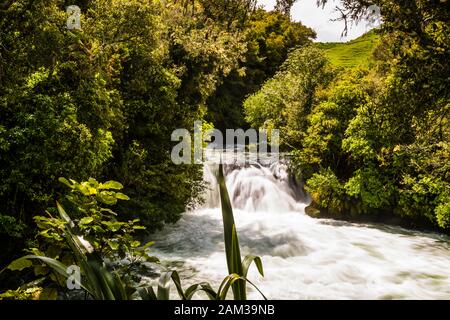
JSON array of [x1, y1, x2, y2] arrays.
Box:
[[0, 0, 450, 299]]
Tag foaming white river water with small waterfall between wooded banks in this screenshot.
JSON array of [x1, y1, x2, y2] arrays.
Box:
[[148, 158, 450, 299]]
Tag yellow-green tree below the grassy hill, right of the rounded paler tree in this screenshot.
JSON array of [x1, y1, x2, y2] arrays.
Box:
[[294, 69, 370, 178]]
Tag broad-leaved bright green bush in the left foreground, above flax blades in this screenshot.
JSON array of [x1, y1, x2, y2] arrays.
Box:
[[34, 178, 157, 264]]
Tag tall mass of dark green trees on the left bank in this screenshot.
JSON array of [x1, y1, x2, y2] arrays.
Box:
[[0, 0, 253, 268]]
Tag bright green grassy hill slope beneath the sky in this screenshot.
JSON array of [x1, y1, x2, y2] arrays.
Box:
[[317, 30, 380, 68]]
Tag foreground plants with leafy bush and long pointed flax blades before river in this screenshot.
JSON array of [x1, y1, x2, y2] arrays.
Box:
[[0, 172, 265, 300]]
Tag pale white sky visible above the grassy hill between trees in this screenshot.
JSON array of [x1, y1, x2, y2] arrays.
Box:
[[258, 0, 370, 42]]
